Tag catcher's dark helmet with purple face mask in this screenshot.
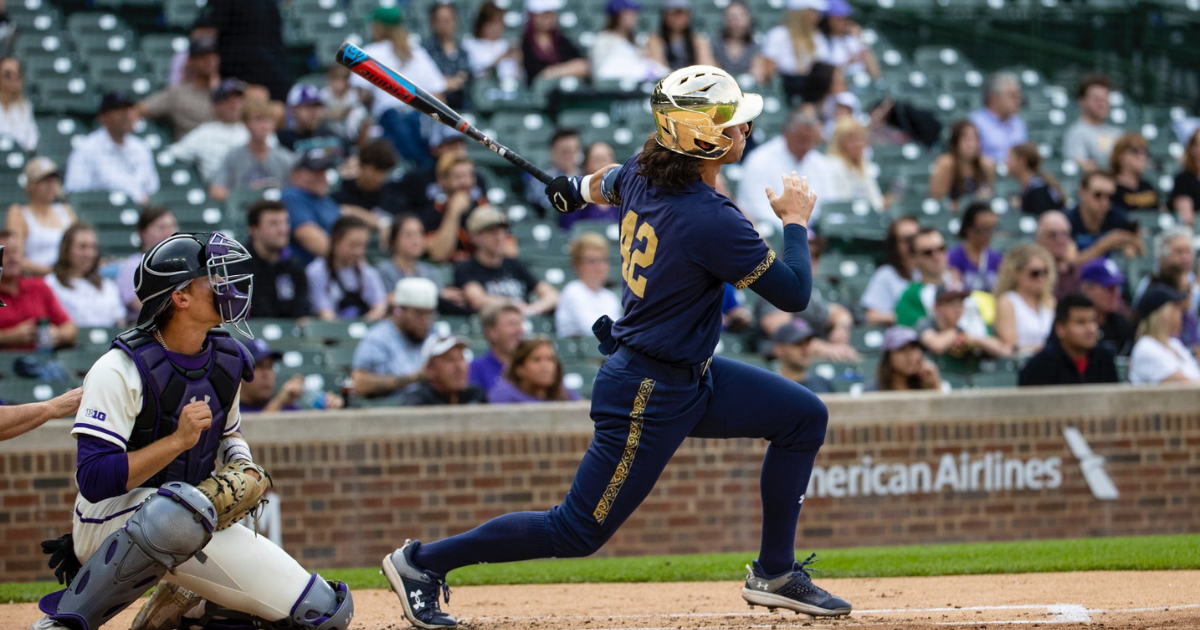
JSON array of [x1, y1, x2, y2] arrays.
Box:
[[133, 232, 254, 337]]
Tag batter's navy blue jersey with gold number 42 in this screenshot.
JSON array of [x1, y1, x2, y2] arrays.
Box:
[[613, 156, 775, 365]]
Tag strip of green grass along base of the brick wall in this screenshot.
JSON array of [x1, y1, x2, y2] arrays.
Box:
[[0, 534, 1200, 601]]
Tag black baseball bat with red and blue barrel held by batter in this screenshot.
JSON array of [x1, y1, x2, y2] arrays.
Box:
[[336, 42, 554, 184]]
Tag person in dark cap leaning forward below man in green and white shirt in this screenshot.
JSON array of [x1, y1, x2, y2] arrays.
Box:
[[916, 284, 1013, 371]]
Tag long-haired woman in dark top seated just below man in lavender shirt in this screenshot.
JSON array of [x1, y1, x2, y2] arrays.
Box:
[[929, 120, 996, 211]]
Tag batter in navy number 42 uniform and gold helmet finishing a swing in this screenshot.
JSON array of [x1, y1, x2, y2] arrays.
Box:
[[383, 66, 851, 629]]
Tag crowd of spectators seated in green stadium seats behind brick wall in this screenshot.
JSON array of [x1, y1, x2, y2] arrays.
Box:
[[0, 0, 1200, 410]]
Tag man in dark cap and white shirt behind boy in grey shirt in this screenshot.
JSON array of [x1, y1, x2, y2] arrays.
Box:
[[164, 79, 250, 182]]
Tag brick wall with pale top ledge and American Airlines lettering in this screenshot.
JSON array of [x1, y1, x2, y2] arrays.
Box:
[[0, 389, 1200, 581]]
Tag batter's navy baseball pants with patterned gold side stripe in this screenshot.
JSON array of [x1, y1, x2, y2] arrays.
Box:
[[414, 354, 828, 575]]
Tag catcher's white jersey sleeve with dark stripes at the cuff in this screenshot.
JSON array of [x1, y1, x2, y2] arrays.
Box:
[[71, 348, 142, 450]]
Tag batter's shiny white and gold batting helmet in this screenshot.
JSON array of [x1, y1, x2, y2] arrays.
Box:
[[650, 66, 762, 160]]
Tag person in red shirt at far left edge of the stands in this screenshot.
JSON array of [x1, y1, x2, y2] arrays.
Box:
[[0, 232, 79, 350]]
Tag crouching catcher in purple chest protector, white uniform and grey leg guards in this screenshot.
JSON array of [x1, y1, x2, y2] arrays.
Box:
[[32, 233, 354, 630]]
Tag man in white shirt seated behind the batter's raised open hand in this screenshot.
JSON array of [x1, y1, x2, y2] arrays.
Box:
[[738, 109, 833, 226]]
